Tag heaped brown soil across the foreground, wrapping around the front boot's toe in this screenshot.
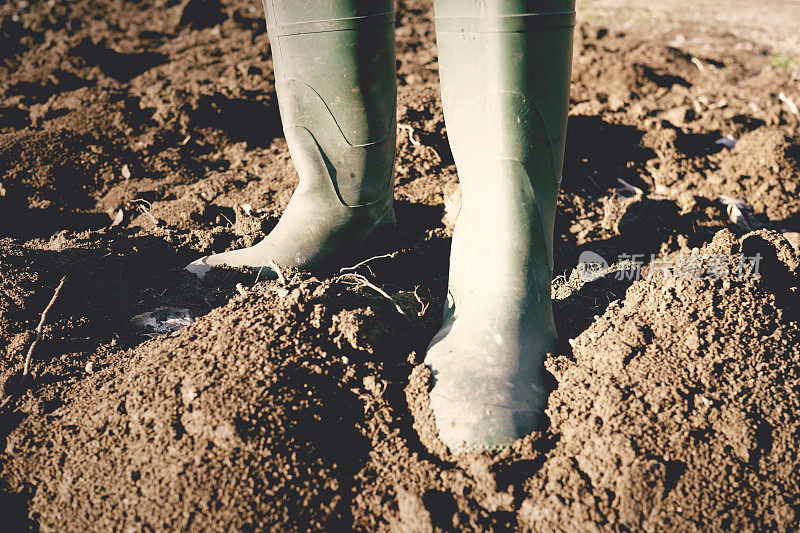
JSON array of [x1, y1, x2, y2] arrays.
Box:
[[6, 231, 800, 530]]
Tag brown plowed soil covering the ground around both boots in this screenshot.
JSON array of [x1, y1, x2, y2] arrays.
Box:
[[0, 0, 800, 531]]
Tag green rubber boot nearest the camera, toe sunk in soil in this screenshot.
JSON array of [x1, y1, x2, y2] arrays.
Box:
[[425, 0, 575, 452]]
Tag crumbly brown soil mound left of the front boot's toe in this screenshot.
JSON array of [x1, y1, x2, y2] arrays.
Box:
[[7, 279, 418, 531]]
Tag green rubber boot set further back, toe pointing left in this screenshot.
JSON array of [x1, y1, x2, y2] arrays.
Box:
[[186, 0, 397, 278]]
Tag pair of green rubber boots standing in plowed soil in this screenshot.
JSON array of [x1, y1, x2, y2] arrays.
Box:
[[187, 0, 575, 452]]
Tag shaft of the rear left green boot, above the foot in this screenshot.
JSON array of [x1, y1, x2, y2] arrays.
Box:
[[264, 0, 397, 207]]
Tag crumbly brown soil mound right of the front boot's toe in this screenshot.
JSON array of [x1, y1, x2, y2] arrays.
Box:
[[536, 231, 800, 531]]
